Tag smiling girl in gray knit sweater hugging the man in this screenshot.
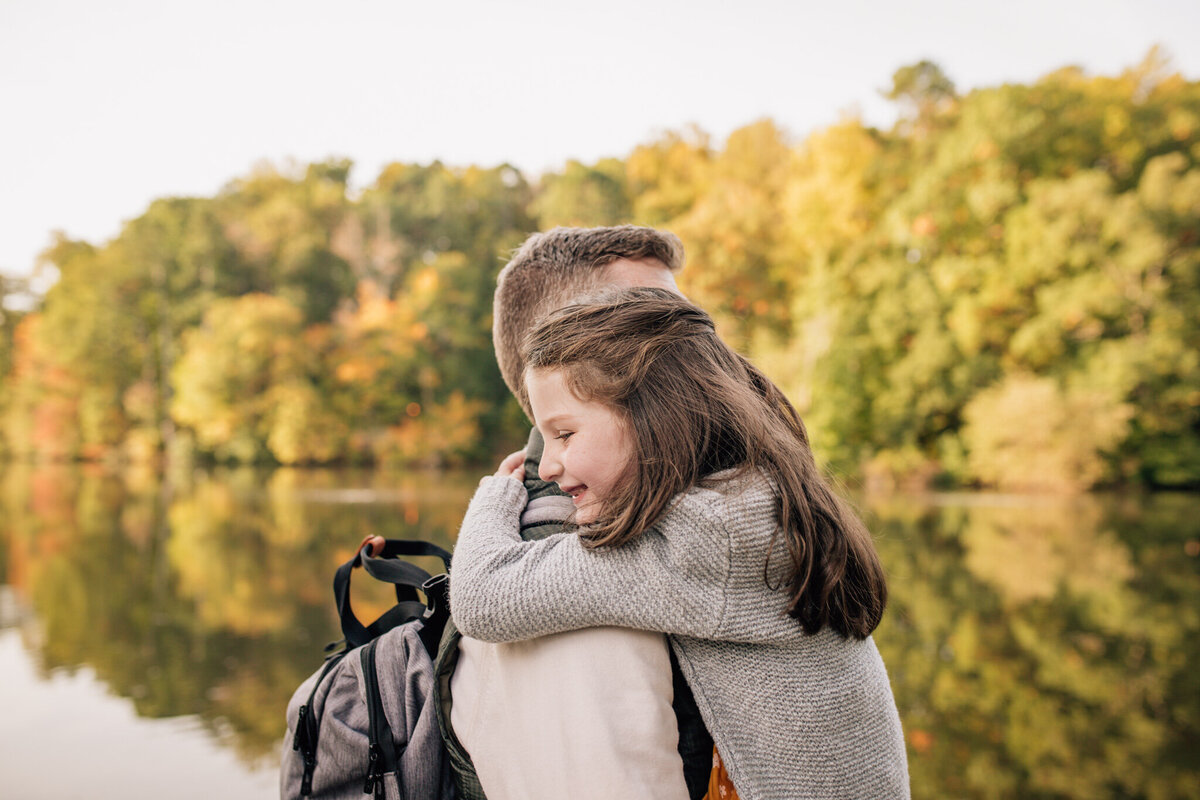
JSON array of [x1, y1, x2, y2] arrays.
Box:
[[450, 289, 908, 800]]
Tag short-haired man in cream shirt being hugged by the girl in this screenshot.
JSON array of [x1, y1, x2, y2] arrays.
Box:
[[437, 225, 713, 800]]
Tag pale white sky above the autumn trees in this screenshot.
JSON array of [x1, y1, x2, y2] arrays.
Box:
[[0, 0, 1200, 281]]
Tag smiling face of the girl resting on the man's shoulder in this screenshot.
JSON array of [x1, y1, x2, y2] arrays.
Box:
[[526, 369, 634, 525]]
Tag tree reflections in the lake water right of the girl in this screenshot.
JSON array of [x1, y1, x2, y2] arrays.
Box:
[[872, 497, 1200, 798]]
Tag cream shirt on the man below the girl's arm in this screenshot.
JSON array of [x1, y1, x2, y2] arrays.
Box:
[[450, 627, 688, 800]]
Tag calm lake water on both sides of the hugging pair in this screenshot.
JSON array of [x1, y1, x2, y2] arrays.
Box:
[[0, 467, 1200, 800]]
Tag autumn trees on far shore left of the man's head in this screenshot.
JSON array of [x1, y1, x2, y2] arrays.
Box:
[[4, 162, 536, 464]]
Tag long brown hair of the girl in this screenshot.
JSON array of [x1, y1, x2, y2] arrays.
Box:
[[523, 288, 887, 638]]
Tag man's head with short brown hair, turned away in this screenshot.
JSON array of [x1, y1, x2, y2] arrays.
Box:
[[492, 225, 683, 414]]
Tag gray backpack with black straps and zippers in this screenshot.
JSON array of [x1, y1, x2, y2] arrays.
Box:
[[280, 539, 457, 800]]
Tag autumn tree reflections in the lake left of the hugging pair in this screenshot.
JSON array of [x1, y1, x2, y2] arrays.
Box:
[[0, 467, 474, 760]]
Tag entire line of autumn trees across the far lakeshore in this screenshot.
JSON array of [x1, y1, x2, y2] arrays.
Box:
[[0, 52, 1200, 489]]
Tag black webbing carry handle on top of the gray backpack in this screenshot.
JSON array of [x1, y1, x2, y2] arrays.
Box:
[[334, 539, 450, 650]]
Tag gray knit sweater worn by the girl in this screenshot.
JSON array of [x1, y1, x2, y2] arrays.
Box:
[[450, 477, 908, 800]]
